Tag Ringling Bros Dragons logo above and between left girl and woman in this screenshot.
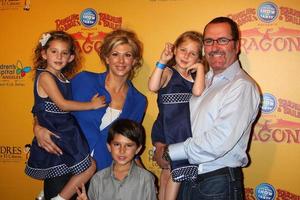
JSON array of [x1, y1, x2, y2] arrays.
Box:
[[55, 8, 122, 54]]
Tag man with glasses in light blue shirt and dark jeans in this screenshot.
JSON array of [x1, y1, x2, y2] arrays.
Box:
[[156, 17, 260, 200]]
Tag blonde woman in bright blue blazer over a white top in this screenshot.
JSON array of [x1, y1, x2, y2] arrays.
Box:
[[34, 30, 146, 198]]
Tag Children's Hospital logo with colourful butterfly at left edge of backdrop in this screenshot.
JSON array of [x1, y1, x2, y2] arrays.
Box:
[[0, 60, 31, 87]]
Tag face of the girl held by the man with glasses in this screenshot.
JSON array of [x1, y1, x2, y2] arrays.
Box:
[[174, 38, 201, 69]]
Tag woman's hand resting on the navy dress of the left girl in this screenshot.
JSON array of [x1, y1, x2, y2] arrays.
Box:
[[33, 120, 63, 155]]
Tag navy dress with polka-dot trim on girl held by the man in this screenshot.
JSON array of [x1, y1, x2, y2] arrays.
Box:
[[151, 68, 198, 182]]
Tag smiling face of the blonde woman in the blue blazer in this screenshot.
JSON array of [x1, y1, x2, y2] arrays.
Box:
[[105, 44, 135, 78]]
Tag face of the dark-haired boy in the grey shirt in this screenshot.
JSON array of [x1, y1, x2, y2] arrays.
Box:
[[107, 134, 142, 167]]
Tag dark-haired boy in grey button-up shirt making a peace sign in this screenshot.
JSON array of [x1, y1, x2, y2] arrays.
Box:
[[77, 119, 156, 200]]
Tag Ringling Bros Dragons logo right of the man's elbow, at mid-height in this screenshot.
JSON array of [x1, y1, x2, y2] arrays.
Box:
[[252, 93, 300, 144]]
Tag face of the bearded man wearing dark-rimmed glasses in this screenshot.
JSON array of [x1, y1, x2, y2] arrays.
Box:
[[204, 23, 239, 74]]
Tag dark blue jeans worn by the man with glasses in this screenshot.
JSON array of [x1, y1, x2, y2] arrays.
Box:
[[177, 168, 244, 200]]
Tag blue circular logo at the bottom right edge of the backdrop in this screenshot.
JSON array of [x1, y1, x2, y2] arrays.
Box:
[[255, 183, 276, 200]]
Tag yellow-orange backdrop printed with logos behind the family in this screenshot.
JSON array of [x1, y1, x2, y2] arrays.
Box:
[[0, 0, 300, 200]]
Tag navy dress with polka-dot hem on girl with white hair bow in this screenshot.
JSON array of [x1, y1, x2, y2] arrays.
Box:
[[25, 70, 91, 179]]
